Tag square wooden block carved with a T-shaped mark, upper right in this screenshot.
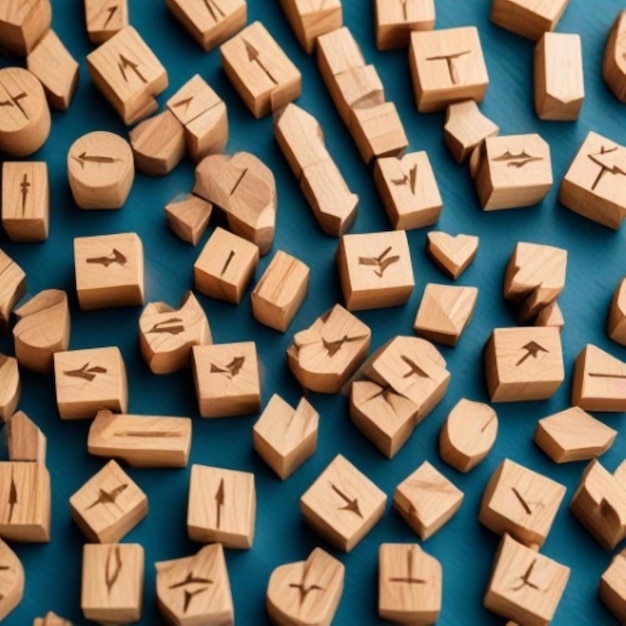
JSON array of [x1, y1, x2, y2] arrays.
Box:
[[409, 26, 489, 113]]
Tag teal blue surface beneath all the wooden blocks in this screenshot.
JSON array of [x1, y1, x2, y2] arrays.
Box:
[[0, 0, 626, 626]]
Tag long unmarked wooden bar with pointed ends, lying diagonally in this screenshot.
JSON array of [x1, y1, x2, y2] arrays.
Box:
[[274, 103, 359, 237]]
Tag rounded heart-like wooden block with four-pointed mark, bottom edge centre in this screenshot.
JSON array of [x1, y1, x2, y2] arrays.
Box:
[[265, 548, 345, 626]]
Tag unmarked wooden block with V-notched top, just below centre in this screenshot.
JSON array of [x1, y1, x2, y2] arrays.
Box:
[[252, 394, 319, 480]]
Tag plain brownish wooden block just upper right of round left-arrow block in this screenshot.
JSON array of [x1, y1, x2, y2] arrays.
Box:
[[129, 109, 187, 176]]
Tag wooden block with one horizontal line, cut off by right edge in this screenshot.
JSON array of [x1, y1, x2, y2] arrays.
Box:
[[572, 344, 626, 413]]
